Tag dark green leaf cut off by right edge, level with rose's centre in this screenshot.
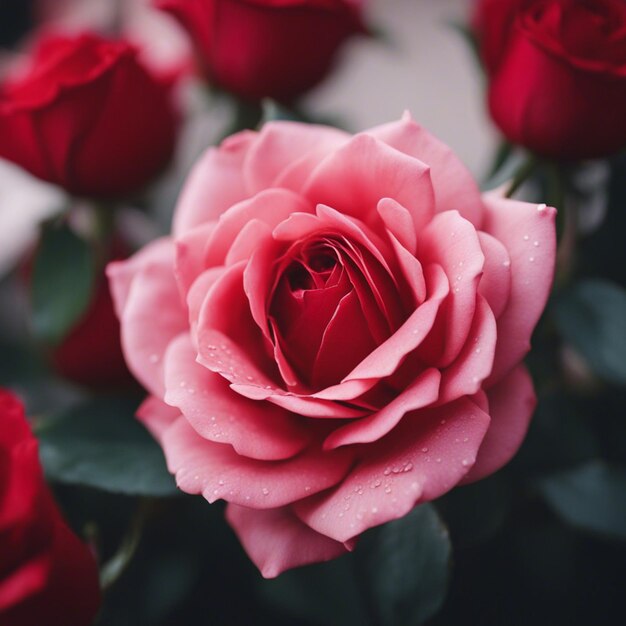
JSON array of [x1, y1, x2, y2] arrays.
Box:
[[552, 280, 626, 384]]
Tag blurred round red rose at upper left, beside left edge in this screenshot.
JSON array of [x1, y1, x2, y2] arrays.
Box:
[[0, 34, 176, 196]]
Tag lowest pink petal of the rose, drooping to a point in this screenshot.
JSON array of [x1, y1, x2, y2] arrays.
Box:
[[226, 504, 348, 578]]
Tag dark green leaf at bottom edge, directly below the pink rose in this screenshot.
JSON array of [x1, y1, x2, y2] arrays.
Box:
[[368, 504, 452, 626]]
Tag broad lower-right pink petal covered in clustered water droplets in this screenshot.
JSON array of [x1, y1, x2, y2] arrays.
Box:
[[294, 398, 490, 542]]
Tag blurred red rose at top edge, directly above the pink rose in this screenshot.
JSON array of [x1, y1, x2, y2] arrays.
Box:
[[156, 0, 364, 102]]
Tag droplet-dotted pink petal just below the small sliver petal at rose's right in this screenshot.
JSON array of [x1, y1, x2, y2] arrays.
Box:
[[439, 296, 497, 404]]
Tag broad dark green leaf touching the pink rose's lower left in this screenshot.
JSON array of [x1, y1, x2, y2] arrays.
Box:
[[37, 396, 176, 496]]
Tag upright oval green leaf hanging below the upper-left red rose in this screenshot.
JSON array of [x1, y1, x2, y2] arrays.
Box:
[[31, 224, 95, 344]]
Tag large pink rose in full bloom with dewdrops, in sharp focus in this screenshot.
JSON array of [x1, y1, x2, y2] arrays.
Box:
[[109, 115, 555, 577]]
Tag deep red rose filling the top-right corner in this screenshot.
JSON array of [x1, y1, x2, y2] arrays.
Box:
[[474, 0, 626, 159]]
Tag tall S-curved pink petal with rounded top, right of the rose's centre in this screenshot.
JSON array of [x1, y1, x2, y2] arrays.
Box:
[[417, 211, 485, 367]]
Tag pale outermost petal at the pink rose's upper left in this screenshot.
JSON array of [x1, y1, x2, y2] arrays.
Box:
[[173, 131, 257, 237]]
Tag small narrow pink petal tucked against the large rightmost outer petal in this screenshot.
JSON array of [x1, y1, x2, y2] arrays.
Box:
[[478, 232, 511, 319]]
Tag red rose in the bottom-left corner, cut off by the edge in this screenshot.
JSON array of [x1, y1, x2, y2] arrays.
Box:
[[0, 389, 100, 626]]
